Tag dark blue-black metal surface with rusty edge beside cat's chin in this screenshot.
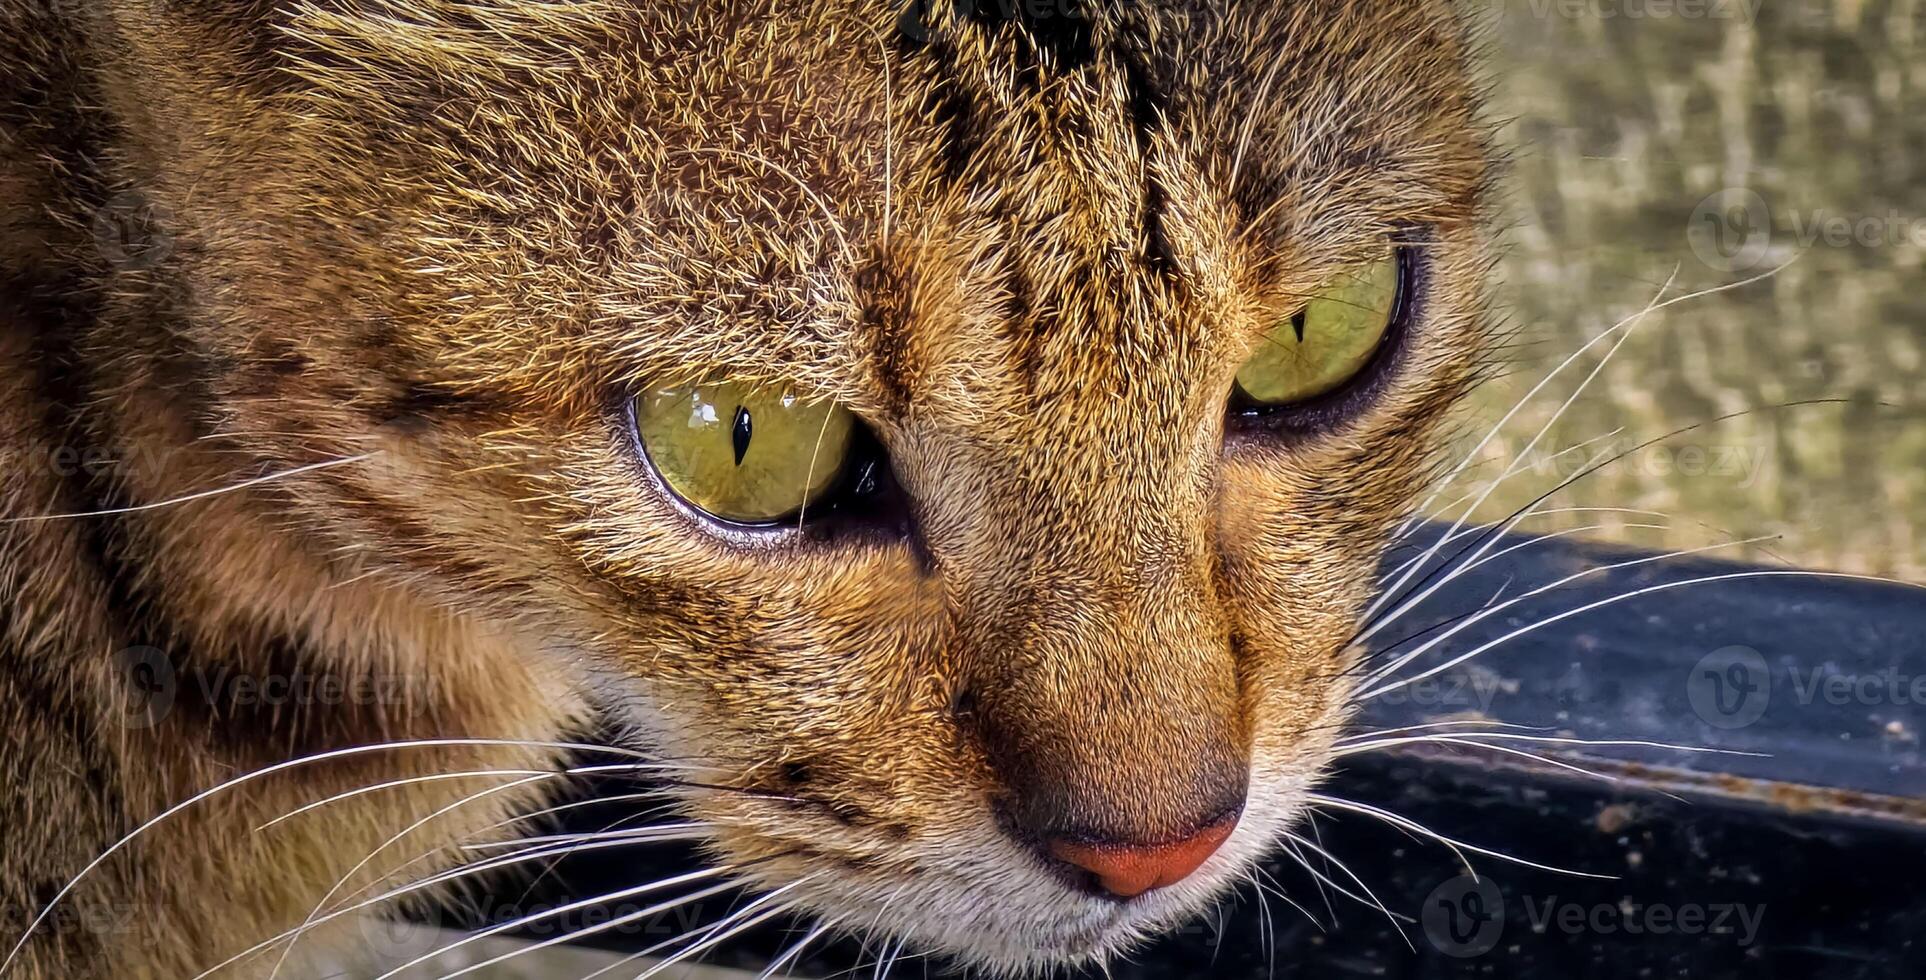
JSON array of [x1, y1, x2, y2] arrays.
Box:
[[466, 541, 1926, 980]]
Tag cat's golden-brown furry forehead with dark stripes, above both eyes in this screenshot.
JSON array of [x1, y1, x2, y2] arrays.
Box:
[[252, 0, 1485, 410]]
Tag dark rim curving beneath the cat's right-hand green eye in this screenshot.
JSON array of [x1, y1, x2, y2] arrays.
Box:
[[1227, 233, 1427, 439]]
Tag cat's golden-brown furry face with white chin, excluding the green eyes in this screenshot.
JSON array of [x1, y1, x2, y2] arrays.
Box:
[[109, 0, 1487, 968]]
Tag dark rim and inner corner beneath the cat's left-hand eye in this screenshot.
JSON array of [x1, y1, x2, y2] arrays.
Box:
[[616, 393, 907, 545]]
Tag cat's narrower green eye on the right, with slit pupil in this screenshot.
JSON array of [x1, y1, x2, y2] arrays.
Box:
[[1236, 252, 1400, 406]]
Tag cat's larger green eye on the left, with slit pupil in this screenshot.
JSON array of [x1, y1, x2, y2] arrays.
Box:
[[636, 383, 855, 524]]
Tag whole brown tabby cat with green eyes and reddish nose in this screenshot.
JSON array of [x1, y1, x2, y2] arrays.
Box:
[[0, 0, 1498, 978]]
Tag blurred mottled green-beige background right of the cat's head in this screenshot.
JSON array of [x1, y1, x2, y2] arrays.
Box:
[[1441, 0, 1926, 580]]
